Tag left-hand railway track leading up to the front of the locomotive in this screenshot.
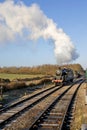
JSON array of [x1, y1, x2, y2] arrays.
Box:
[[0, 86, 62, 128]]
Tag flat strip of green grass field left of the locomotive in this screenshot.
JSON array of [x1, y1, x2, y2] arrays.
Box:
[[0, 73, 43, 80]]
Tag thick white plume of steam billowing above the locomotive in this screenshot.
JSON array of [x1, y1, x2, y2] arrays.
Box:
[[0, 0, 78, 64]]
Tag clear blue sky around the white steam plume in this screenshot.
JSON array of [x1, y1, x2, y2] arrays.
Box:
[[0, 0, 87, 68]]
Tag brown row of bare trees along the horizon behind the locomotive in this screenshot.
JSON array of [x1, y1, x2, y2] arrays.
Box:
[[0, 64, 84, 75]]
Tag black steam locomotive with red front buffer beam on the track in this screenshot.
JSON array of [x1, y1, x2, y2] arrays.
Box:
[[52, 68, 74, 86]]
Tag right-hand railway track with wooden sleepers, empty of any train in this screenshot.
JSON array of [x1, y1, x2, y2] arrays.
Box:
[[26, 79, 82, 130]]
